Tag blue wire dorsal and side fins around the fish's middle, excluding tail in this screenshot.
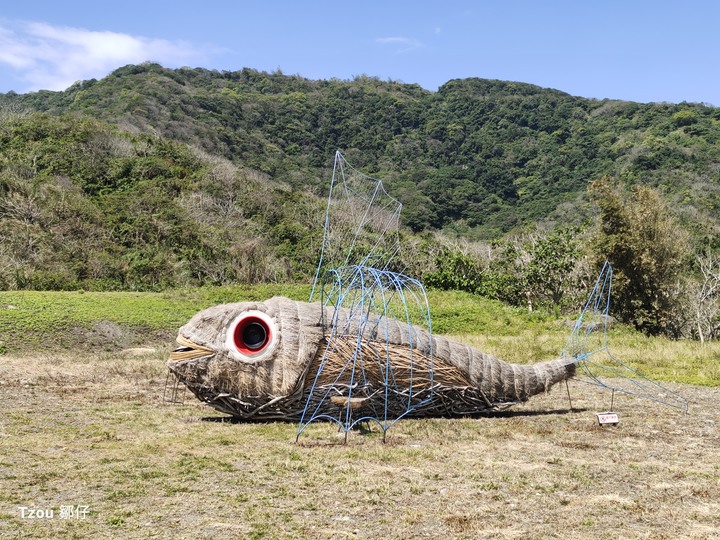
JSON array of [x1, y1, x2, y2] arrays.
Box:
[[297, 151, 434, 438]]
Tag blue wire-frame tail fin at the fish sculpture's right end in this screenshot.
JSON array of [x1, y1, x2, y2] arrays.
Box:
[[562, 262, 688, 412]]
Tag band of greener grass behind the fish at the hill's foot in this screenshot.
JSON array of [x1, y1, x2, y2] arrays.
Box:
[[0, 284, 720, 386]]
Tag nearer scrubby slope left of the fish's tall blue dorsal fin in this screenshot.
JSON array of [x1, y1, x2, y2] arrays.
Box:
[[0, 110, 322, 290]]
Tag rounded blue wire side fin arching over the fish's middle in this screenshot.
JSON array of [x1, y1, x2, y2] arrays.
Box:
[[298, 265, 433, 436]]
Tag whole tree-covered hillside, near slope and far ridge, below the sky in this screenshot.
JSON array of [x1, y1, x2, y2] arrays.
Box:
[[0, 64, 720, 304]]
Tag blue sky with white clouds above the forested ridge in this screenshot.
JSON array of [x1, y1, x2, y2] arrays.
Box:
[[0, 0, 720, 106]]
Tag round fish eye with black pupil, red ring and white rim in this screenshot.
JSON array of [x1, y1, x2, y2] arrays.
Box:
[[225, 310, 278, 362]]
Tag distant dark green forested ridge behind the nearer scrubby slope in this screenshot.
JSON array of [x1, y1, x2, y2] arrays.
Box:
[[3, 64, 720, 238]]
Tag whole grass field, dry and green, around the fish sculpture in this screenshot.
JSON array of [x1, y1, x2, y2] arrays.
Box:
[[0, 286, 720, 539]]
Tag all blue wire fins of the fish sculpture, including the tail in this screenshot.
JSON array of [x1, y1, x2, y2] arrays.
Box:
[[297, 152, 688, 438]]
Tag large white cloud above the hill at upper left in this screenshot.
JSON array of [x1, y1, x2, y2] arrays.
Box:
[[0, 21, 207, 91]]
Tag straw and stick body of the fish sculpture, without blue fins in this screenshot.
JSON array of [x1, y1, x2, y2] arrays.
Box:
[[168, 297, 575, 420]]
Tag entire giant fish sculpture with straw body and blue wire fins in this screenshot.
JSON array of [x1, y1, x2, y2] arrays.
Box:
[[168, 151, 687, 426]]
